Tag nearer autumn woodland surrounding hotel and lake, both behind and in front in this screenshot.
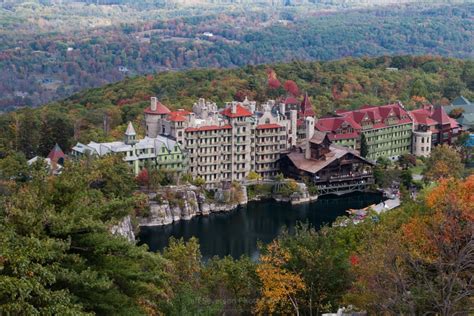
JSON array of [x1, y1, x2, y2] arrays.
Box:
[[0, 51, 474, 316]]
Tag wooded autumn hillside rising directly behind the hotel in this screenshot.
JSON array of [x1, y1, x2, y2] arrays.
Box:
[[0, 56, 474, 157]]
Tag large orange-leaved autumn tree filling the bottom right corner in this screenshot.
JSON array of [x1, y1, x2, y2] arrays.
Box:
[[345, 176, 474, 316]]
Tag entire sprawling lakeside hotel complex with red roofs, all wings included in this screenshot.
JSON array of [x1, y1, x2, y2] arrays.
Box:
[[73, 95, 459, 191]]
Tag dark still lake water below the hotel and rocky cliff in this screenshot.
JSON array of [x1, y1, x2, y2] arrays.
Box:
[[139, 193, 382, 259]]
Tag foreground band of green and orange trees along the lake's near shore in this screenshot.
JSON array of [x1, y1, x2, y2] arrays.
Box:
[[0, 146, 474, 316]]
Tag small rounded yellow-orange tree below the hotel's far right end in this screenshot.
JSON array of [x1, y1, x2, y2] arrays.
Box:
[[424, 144, 464, 181]]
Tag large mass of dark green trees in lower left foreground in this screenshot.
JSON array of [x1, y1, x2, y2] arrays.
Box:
[[0, 158, 166, 315]]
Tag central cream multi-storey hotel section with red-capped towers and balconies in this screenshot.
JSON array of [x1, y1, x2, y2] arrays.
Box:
[[145, 98, 302, 184]]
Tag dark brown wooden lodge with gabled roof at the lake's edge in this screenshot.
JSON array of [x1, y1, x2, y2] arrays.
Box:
[[280, 123, 374, 195]]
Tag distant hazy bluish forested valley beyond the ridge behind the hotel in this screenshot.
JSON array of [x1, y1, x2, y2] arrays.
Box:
[[0, 1, 474, 111]]
